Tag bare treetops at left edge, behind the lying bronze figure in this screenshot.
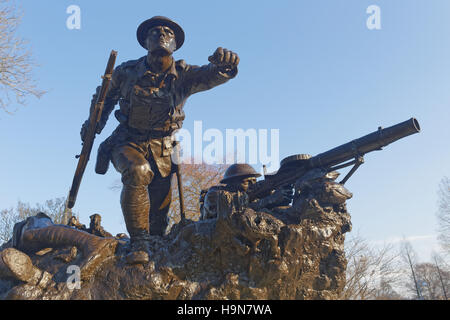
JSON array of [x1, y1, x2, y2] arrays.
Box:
[[0, 198, 74, 244]]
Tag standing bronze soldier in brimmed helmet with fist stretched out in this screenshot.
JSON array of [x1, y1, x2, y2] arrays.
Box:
[[81, 16, 239, 263]]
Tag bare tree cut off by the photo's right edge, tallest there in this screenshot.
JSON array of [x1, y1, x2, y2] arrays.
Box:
[[437, 177, 450, 254]]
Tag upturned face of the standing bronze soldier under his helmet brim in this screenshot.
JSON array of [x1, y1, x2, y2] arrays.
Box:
[[146, 26, 177, 55]]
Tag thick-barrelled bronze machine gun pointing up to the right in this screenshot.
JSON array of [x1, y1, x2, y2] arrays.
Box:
[[247, 118, 420, 201]]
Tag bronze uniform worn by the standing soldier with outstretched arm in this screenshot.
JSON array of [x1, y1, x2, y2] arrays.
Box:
[[89, 16, 237, 250]]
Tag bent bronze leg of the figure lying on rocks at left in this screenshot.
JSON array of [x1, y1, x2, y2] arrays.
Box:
[[19, 225, 117, 280]]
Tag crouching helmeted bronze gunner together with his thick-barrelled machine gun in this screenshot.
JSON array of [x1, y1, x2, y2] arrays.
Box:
[[200, 118, 420, 219]]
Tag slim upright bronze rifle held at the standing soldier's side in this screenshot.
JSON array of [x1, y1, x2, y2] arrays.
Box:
[[67, 50, 117, 209]]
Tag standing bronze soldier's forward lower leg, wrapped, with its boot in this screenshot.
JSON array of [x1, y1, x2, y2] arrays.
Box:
[[120, 185, 150, 264]]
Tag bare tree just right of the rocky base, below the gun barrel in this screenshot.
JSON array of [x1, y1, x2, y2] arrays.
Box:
[[340, 234, 401, 300]]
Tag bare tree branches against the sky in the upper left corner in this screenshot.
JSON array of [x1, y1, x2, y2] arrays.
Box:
[[0, 0, 45, 113]]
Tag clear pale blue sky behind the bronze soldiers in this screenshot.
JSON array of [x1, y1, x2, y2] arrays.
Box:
[[0, 0, 450, 259]]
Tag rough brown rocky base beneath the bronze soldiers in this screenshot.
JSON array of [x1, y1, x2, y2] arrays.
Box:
[[0, 196, 351, 299]]
